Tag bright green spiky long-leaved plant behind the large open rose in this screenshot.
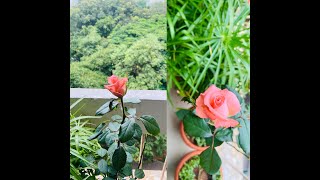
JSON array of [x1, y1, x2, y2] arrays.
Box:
[[167, 0, 250, 103]]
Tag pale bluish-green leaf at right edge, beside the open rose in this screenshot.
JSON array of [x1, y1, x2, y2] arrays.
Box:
[[236, 118, 250, 155]]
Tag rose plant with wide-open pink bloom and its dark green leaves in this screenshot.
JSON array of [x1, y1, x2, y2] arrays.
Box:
[[176, 85, 250, 175]]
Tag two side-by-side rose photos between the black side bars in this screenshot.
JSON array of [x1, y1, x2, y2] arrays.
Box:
[[70, 0, 250, 180]]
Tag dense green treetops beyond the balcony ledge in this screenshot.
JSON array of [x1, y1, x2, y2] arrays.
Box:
[[70, 0, 167, 89]]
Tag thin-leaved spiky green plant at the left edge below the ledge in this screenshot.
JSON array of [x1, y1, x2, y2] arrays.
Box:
[[70, 99, 100, 180]]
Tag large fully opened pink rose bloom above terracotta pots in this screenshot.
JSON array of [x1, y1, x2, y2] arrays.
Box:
[[196, 85, 240, 128]]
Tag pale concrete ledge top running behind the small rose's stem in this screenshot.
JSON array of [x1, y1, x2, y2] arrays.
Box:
[[70, 88, 167, 101]]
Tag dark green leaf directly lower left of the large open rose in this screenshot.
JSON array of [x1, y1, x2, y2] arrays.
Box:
[[182, 114, 212, 137]]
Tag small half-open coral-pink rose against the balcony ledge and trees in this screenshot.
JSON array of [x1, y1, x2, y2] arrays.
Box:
[[104, 75, 128, 98]]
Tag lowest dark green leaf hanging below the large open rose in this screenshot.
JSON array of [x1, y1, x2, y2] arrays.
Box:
[[200, 146, 221, 175]]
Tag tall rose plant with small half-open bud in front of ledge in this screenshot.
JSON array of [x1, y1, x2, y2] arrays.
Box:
[[89, 75, 160, 180]]
